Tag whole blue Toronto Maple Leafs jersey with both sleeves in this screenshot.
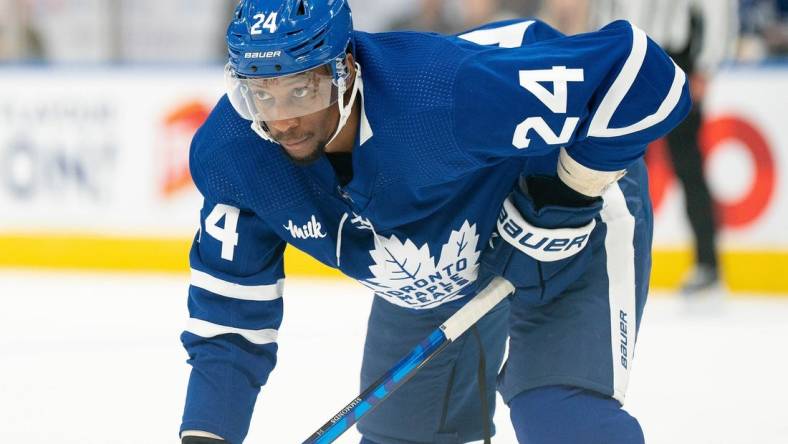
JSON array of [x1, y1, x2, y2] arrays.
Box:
[[181, 20, 690, 442]]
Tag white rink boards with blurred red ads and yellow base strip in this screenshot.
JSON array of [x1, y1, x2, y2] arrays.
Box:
[[0, 65, 788, 293]]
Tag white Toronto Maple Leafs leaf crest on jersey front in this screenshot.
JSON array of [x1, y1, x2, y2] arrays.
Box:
[[362, 220, 480, 309]]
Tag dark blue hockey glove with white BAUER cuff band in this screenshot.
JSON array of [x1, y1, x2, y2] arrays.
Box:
[[482, 176, 602, 305]]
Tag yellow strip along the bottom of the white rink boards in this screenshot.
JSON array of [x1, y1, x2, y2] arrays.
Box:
[[0, 235, 788, 295]]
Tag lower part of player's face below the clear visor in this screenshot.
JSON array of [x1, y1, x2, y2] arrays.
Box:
[[266, 99, 339, 165]]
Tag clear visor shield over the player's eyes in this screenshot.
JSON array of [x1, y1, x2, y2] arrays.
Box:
[[224, 64, 339, 122]]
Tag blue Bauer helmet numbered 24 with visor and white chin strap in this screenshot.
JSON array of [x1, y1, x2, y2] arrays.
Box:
[[225, 0, 359, 141]]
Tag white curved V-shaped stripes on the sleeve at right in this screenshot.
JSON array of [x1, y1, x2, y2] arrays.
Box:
[[588, 26, 686, 137]]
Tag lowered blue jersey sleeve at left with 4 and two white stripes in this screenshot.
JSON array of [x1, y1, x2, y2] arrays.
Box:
[[181, 147, 285, 442]]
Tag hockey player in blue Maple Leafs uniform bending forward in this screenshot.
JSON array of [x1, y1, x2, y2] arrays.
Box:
[[181, 0, 690, 444]]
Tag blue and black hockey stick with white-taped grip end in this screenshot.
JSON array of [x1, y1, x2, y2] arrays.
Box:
[[303, 277, 514, 444]]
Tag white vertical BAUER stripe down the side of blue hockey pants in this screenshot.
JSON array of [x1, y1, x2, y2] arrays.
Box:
[[601, 183, 637, 403]]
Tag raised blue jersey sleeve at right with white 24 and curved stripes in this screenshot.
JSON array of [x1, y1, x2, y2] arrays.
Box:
[[453, 20, 691, 184]]
